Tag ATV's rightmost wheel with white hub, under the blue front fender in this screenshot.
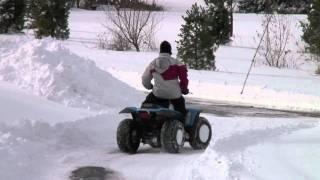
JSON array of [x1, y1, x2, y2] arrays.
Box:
[[189, 117, 212, 149]]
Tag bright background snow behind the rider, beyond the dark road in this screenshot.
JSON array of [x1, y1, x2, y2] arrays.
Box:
[[66, 11, 320, 111]]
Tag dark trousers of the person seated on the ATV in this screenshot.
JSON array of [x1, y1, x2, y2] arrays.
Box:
[[142, 92, 187, 117]]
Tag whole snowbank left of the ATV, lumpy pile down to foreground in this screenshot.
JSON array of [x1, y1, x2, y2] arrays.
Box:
[[0, 36, 143, 180]]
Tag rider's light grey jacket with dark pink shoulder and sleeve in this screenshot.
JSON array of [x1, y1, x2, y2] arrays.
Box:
[[142, 53, 189, 99]]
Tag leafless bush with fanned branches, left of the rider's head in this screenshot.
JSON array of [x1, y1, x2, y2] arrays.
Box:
[[105, 0, 160, 51]]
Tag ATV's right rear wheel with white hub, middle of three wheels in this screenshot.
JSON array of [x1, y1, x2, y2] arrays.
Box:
[[160, 120, 185, 153]]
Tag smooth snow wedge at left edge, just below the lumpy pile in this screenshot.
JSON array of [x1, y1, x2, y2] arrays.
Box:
[[0, 81, 94, 125]]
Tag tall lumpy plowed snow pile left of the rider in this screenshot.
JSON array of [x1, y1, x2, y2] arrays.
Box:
[[0, 38, 142, 110]]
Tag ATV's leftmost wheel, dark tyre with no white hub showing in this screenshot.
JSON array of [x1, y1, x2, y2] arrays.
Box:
[[117, 119, 141, 154]]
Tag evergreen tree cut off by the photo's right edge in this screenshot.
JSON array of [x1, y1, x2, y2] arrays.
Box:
[[302, 0, 320, 57]]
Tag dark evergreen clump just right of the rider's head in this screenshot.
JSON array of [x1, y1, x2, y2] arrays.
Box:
[[177, 0, 233, 70]]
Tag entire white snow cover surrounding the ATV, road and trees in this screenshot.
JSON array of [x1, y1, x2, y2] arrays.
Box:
[[0, 1, 320, 180]]
